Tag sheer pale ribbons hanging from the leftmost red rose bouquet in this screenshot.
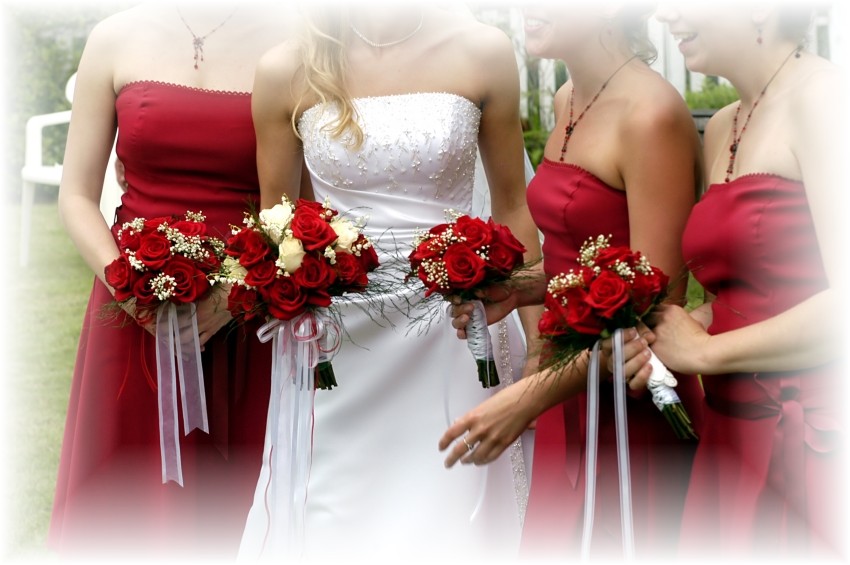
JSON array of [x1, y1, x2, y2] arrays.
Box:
[[156, 302, 209, 487]]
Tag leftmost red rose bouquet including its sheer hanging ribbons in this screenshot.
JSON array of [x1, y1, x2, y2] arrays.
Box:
[[104, 212, 224, 486]]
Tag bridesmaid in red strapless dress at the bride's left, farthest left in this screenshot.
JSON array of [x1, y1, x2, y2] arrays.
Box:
[[48, 2, 289, 559]]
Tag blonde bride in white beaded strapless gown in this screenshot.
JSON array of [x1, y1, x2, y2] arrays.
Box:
[[241, 2, 540, 559]]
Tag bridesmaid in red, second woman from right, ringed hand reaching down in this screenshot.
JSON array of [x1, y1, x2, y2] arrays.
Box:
[[440, 3, 700, 558]]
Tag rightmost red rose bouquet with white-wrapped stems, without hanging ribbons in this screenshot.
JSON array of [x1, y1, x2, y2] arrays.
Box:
[[538, 235, 697, 439]]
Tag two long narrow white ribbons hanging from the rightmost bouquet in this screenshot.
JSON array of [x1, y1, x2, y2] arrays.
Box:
[[581, 329, 635, 561]]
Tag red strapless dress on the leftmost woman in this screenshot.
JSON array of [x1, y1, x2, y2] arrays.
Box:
[[48, 81, 271, 559]]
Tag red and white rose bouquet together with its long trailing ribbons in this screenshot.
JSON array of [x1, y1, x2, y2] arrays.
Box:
[[219, 197, 378, 547]]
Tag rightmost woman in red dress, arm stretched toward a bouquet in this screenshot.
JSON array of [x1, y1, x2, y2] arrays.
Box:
[[653, 2, 847, 558]]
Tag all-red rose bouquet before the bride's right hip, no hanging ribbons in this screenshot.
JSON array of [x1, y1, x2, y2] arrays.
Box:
[[408, 210, 525, 388]]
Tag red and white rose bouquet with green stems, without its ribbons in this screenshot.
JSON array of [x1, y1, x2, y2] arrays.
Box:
[[217, 197, 378, 389]]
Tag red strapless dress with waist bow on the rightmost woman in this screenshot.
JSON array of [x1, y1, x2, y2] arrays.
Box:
[[682, 174, 847, 559]]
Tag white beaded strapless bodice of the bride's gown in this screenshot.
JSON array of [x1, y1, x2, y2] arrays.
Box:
[[298, 92, 481, 253]]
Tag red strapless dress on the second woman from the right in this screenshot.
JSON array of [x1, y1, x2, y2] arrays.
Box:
[[522, 159, 702, 559]]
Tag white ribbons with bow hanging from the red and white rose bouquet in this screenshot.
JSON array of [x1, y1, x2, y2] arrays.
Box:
[[257, 310, 340, 557]]
